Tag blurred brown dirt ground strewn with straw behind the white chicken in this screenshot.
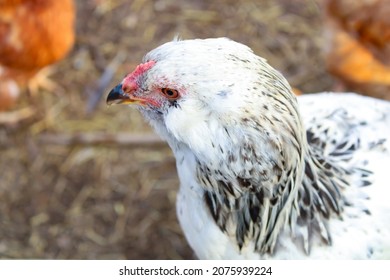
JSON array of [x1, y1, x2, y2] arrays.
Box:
[[0, 0, 334, 259]]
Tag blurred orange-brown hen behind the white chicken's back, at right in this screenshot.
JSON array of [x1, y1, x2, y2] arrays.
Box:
[[324, 0, 390, 100]]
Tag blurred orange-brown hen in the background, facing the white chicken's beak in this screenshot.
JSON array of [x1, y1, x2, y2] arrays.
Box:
[[0, 0, 75, 111]]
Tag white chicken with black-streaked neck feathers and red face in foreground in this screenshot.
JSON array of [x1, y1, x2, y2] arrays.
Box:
[[107, 38, 390, 259]]
